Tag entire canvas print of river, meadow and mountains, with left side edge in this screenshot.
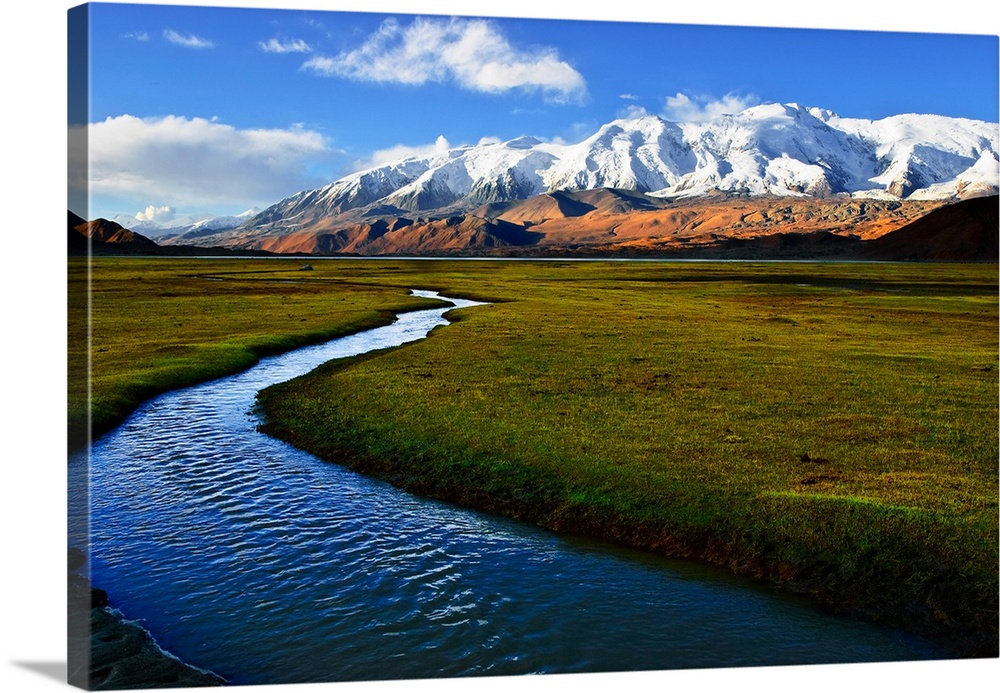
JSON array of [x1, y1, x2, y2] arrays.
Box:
[[67, 3, 1000, 690]]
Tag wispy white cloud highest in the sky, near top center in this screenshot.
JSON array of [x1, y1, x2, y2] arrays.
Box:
[[302, 18, 586, 103]]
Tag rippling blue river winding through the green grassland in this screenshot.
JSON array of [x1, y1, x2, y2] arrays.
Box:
[[70, 292, 950, 684]]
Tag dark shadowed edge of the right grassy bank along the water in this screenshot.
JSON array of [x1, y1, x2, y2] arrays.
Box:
[[261, 393, 998, 657]]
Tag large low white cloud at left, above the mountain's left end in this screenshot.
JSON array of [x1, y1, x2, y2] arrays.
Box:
[[70, 115, 334, 209]]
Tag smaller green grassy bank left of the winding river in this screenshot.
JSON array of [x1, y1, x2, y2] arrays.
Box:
[[68, 257, 436, 447]]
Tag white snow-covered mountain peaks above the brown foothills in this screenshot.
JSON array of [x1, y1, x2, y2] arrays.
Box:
[[242, 104, 1000, 234]]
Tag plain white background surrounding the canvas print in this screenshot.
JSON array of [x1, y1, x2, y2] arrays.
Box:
[[0, 0, 1000, 693]]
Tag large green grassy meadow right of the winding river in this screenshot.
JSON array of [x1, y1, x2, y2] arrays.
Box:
[[254, 261, 998, 656]]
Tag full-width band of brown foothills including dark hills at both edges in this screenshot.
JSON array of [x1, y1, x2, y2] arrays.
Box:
[[69, 195, 1000, 262]]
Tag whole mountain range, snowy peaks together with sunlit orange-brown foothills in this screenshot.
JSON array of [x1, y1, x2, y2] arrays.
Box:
[[99, 104, 1000, 254]]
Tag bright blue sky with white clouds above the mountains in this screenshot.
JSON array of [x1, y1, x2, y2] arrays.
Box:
[[72, 4, 998, 222]]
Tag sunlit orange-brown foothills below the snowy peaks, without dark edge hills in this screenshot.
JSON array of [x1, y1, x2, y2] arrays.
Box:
[[184, 189, 943, 255]]
